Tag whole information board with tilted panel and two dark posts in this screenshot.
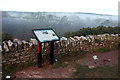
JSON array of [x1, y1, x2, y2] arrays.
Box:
[[32, 28, 60, 67]]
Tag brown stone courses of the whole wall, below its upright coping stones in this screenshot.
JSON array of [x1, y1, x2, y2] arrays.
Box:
[[2, 34, 120, 65]]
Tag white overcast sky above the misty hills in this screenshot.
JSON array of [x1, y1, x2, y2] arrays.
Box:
[[0, 0, 119, 15]]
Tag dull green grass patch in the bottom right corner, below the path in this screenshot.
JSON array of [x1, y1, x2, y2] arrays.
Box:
[[73, 64, 118, 78]]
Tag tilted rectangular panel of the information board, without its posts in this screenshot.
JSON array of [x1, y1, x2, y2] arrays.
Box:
[[33, 29, 59, 42]]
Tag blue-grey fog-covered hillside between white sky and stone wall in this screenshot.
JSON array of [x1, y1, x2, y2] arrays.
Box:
[[2, 11, 118, 39]]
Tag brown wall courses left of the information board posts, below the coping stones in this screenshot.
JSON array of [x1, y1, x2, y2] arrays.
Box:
[[2, 48, 37, 65]]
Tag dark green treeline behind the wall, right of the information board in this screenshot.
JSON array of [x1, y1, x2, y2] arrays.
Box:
[[64, 25, 120, 38]]
